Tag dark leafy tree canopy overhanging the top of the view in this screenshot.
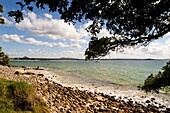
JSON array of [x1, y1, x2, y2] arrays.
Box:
[[9, 0, 170, 59]]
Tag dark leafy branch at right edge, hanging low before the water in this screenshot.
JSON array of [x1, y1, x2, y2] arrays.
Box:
[[139, 61, 170, 93]]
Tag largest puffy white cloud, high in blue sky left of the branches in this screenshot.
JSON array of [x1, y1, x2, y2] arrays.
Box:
[[16, 12, 88, 40]]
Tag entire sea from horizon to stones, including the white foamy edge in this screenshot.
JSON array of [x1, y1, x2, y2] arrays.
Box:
[[11, 59, 170, 107]]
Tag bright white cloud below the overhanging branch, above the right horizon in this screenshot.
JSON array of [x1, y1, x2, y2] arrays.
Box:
[[106, 38, 170, 59]]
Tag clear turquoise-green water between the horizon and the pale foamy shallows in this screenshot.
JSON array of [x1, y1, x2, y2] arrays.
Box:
[[12, 60, 168, 86]]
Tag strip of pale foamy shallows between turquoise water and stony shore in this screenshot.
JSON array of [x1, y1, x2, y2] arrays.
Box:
[[42, 70, 170, 108]]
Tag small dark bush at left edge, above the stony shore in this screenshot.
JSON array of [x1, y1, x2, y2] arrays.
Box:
[[0, 47, 10, 66]]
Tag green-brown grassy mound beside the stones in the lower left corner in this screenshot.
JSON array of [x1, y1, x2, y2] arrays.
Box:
[[0, 78, 49, 113]]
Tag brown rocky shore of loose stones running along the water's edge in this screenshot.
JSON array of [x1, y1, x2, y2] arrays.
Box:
[[0, 66, 170, 113]]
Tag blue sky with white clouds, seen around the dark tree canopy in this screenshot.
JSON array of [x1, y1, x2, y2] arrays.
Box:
[[0, 0, 170, 59]]
